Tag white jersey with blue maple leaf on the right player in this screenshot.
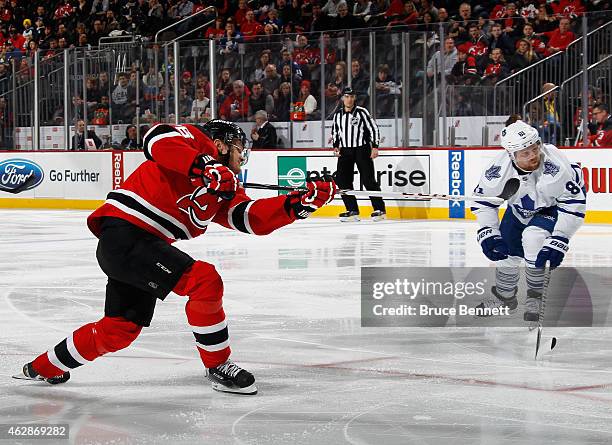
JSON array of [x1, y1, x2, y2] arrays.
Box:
[[472, 144, 586, 239]]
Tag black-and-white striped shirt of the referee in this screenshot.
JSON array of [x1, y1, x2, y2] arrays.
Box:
[[332, 106, 380, 148]]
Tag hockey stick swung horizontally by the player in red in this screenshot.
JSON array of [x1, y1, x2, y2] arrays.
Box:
[[242, 178, 521, 204]]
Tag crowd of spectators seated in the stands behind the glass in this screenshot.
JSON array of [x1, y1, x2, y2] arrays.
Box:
[[0, 0, 612, 147]]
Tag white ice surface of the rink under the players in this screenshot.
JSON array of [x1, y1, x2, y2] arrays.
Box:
[[0, 210, 612, 445]]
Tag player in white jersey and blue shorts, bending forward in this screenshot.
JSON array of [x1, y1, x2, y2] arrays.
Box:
[[472, 120, 586, 321]]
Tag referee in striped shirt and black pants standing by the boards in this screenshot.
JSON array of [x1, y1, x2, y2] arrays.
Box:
[[332, 87, 386, 221]]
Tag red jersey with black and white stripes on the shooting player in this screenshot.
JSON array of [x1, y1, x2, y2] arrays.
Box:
[[87, 124, 296, 243]]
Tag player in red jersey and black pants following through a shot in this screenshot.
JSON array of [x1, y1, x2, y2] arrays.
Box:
[[16, 120, 336, 394]]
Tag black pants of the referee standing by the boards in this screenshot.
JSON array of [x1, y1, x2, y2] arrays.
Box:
[[336, 145, 385, 212]]
